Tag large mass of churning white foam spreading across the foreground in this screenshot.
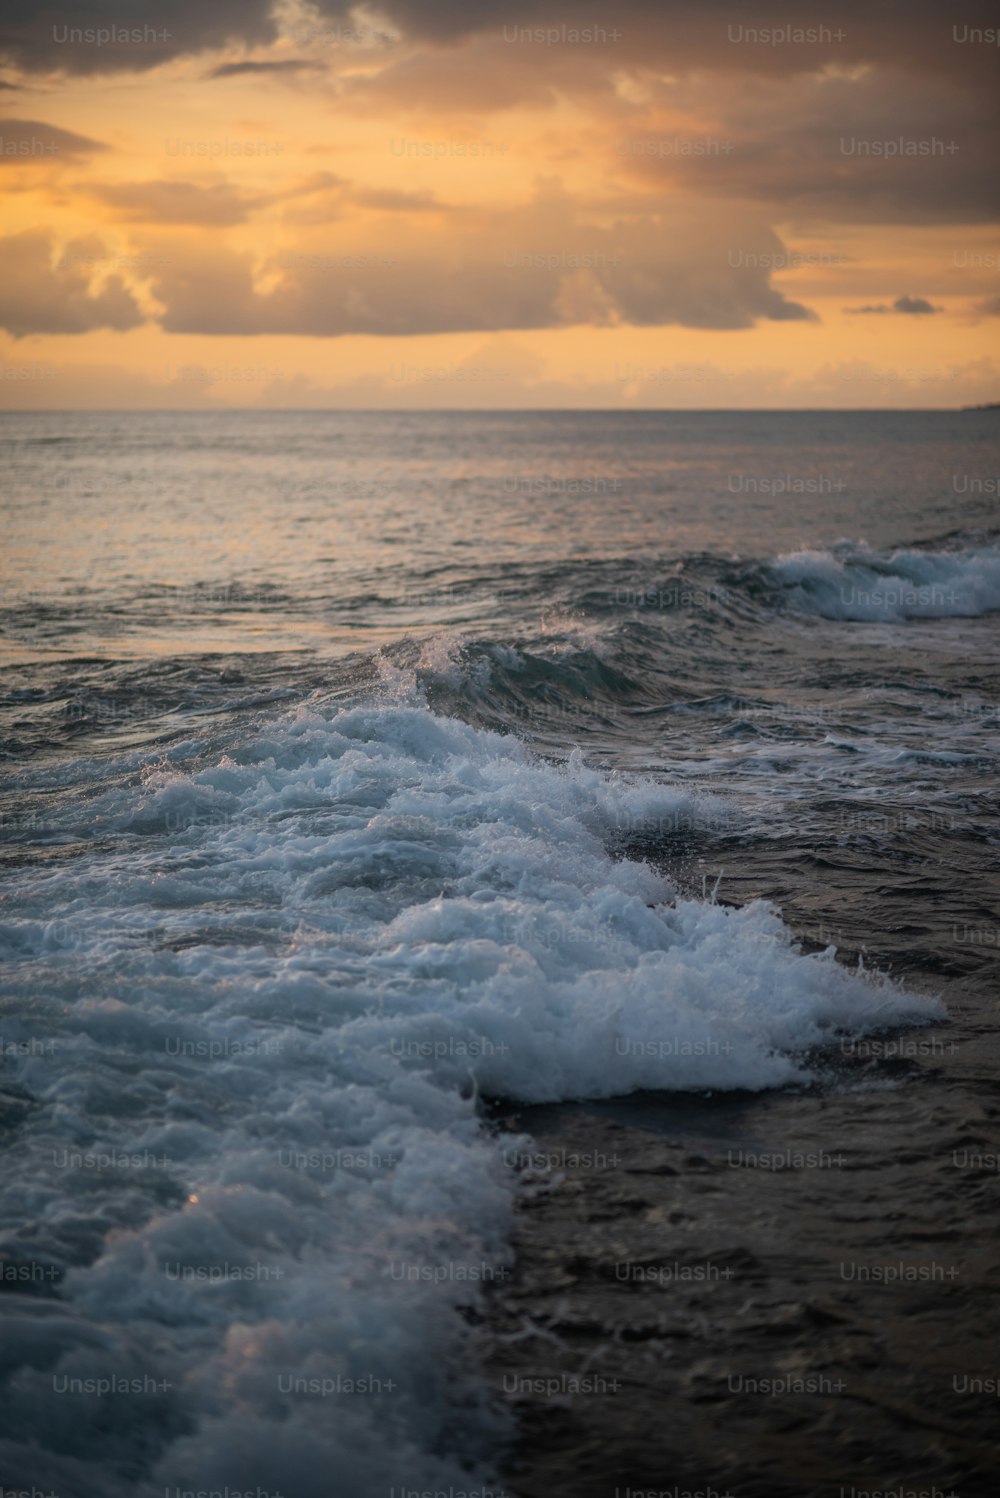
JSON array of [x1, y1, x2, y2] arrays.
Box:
[[0, 695, 942, 1498]]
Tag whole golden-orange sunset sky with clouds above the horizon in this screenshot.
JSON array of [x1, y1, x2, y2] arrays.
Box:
[[0, 0, 1000, 409]]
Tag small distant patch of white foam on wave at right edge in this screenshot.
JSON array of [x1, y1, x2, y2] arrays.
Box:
[[772, 542, 1000, 622]]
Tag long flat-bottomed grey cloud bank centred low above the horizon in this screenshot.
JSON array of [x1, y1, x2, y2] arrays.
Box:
[[154, 183, 814, 337]]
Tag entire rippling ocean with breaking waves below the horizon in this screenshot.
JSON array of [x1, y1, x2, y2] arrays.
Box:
[[0, 410, 1000, 1498]]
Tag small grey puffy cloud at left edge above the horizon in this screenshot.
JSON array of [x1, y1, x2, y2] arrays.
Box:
[[0, 229, 144, 339]]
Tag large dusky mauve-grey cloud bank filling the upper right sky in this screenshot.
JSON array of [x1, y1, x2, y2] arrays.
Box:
[[314, 21, 1000, 232]]
